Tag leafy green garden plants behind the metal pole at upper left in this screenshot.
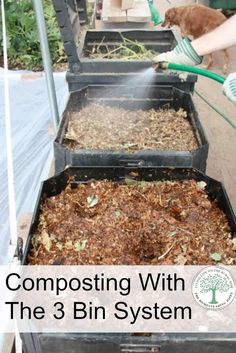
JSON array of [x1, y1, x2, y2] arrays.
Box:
[[0, 0, 65, 70]]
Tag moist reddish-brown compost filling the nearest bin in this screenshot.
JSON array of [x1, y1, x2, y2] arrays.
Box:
[[28, 179, 236, 265]]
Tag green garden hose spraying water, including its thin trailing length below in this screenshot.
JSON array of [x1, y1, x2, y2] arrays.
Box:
[[154, 62, 236, 129]]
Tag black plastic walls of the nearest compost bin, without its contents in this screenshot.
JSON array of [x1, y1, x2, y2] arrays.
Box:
[[21, 167, 236, 353]]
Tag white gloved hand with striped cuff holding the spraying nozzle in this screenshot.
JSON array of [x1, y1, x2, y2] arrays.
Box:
[[153, 38, 203, 66]]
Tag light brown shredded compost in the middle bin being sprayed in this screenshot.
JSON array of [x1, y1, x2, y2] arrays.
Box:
[[63, 103, 198, 153]]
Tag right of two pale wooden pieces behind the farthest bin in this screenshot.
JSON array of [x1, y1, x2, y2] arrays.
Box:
[[127, 0, 151, 22]]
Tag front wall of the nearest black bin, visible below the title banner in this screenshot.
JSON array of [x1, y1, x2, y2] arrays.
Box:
[[22, 333, 236, 353]]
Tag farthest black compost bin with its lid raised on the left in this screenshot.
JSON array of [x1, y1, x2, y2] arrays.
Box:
[[52, 0, 197, 91]]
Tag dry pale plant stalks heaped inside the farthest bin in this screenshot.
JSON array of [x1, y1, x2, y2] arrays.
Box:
[[84, 35, 158, 60]]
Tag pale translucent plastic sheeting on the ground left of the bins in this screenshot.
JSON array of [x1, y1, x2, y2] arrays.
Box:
[[0, 69, 68, 264]]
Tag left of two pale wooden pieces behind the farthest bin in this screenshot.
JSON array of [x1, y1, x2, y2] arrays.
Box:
[[102, 0, 127, 22]]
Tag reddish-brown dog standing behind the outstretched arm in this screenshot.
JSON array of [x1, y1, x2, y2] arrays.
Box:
[[162, 5, 229, 72]]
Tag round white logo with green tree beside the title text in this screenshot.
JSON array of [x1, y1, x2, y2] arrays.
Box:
[[192, 266, 236, 310]]
